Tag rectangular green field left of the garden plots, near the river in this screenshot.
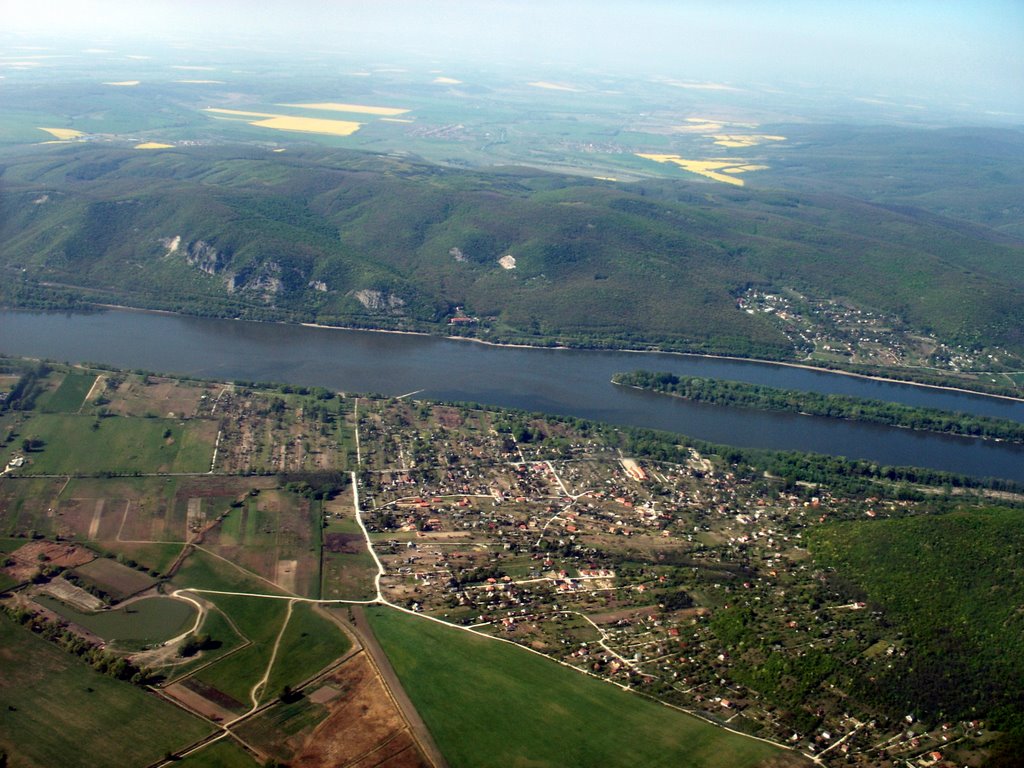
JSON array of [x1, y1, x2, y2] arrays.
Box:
[[14, 414, 213, 474]]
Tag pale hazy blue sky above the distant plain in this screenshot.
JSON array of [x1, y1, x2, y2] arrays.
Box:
[[0, 0, 1024, 112]]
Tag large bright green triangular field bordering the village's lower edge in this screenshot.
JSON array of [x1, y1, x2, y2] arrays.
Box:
[[368, 607, 780, 768]]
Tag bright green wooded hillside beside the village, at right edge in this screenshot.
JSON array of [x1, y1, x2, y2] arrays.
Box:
[[810, 509, 1024, 730]]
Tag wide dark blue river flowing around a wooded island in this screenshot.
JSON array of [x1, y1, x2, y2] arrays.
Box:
[[6, 310, 1024, 482]]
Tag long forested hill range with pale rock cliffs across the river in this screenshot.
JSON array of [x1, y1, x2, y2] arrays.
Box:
[[0, 144, 1024, 357]]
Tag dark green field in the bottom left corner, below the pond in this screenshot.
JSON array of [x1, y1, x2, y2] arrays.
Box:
[[0, 616, 211, 768]]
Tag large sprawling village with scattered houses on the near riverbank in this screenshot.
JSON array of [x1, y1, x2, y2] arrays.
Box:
[[357, 400, 980, 766]]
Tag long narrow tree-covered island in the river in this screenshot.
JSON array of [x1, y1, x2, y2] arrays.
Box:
[[612, 371, 1024, 442]]
